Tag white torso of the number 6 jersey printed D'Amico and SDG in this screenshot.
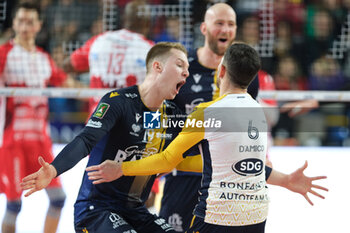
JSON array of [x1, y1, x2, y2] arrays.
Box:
[[195, 94, 268, 226]]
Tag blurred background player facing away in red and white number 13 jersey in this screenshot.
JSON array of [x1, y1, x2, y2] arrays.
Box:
[[64, 0, 154, 114]]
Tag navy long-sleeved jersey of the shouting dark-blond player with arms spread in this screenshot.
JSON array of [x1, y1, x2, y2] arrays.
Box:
[[52, 86, 180, 222]]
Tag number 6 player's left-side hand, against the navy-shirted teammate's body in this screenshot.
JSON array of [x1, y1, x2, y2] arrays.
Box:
[[85, 160, 123, 184]]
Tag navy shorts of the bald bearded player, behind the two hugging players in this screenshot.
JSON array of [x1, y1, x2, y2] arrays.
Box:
[[159, 174, 202, 232]]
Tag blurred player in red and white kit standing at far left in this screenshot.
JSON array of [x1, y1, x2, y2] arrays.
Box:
[[0, 2, 66, 233]]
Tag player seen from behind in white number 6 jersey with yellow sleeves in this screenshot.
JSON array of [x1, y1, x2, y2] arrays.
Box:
[[87, 44, 327, 233]]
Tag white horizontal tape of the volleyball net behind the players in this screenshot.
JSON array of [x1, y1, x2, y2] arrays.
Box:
[[0, 87, 350, 102]]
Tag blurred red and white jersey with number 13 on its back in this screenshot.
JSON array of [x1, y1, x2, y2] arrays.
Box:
[[70, 29, 154, 113]]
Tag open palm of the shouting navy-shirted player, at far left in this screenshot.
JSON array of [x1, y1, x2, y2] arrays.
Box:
[[20, 156, 57, 197]]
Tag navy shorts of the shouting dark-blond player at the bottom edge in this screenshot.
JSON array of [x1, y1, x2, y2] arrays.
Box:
[[75, 208, 175, 233]]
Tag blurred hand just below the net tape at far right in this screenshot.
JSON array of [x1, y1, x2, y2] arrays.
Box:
[[280, 99, 319, 117]]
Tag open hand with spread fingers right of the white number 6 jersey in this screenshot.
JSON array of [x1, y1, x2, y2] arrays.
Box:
[[286, 161, 328, 205]]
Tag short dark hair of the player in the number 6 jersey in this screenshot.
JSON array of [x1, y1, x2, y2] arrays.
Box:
[[223, 43, 261, 89]]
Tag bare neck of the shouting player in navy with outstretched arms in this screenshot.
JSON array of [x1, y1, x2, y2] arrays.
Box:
[[138, 80, 164, 111]]
